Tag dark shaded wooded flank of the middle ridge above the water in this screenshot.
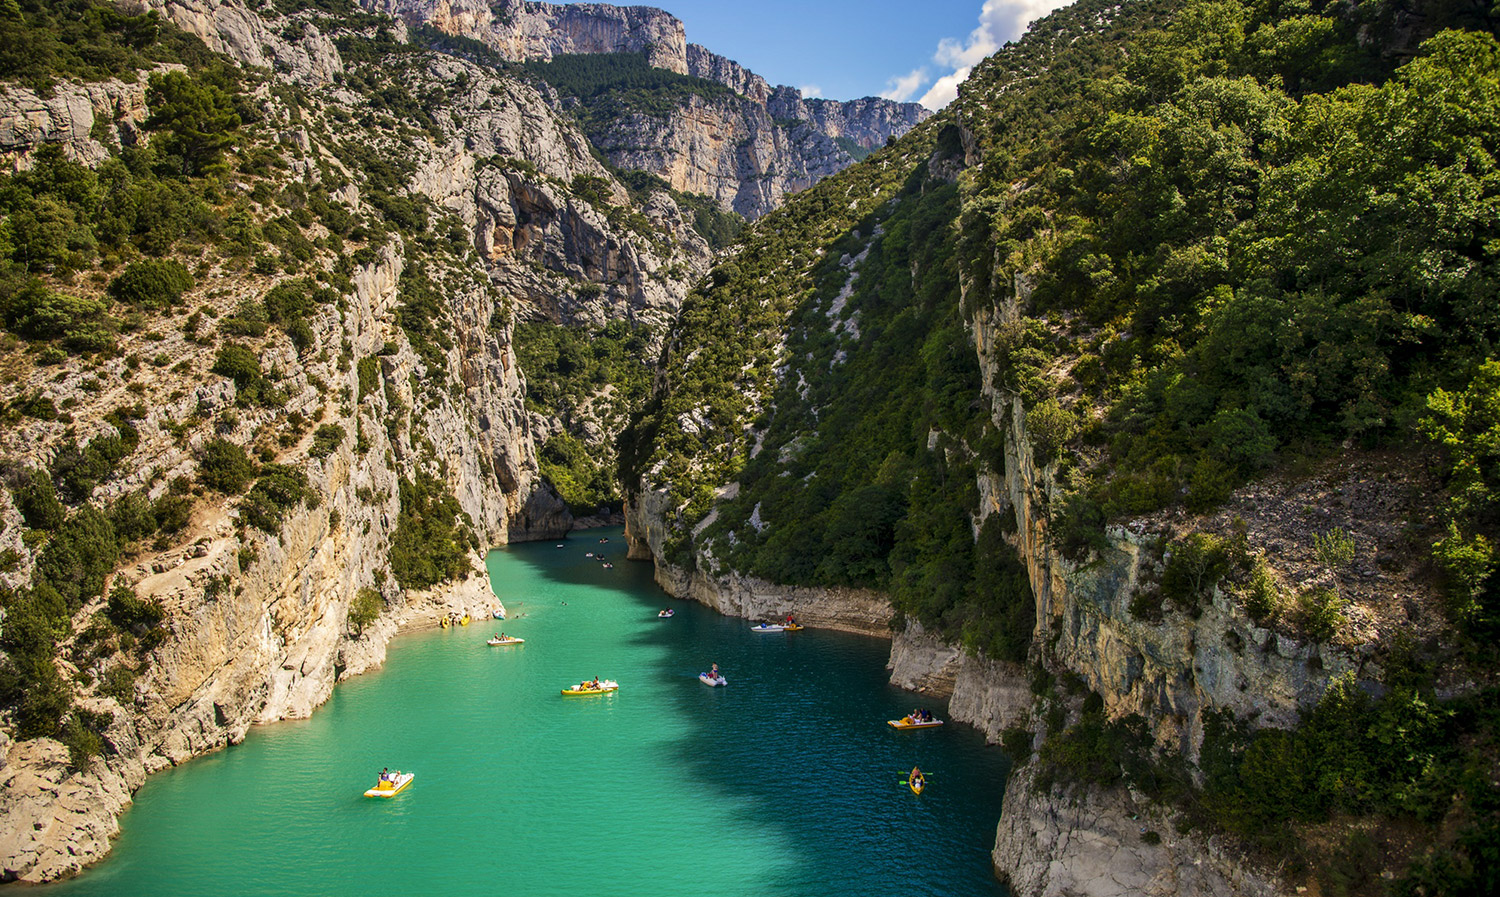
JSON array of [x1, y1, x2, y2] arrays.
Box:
[[698, 156, 1035, 662]]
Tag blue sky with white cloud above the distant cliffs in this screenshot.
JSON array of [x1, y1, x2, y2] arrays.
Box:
[[564, 0, 1070, 110]]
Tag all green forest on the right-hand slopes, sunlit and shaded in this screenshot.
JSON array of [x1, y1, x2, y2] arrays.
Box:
[[624, 0, 1500, 894]]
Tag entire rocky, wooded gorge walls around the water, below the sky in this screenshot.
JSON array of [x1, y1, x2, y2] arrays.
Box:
[[0, 0, 1500, 896]]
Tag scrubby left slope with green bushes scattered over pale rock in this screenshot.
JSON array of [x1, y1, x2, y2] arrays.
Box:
[[0, 0, 621, 768]]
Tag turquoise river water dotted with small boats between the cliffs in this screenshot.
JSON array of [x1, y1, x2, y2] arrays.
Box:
[[39, 530, 1007, 897]]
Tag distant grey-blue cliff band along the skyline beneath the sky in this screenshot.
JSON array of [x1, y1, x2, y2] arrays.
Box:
[[366, 0, 930, 219]]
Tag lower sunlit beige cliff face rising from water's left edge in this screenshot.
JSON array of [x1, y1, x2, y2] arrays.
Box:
[[0, 226, 528, 881]]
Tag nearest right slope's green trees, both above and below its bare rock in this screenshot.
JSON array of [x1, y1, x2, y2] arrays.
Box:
[[936, 2, 1500, 894]]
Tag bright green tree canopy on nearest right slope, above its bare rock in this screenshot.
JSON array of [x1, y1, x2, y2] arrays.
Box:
[[962, 3, 1500, 612]]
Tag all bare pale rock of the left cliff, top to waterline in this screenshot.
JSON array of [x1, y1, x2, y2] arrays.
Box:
[[0, 2, 720, 881]]
